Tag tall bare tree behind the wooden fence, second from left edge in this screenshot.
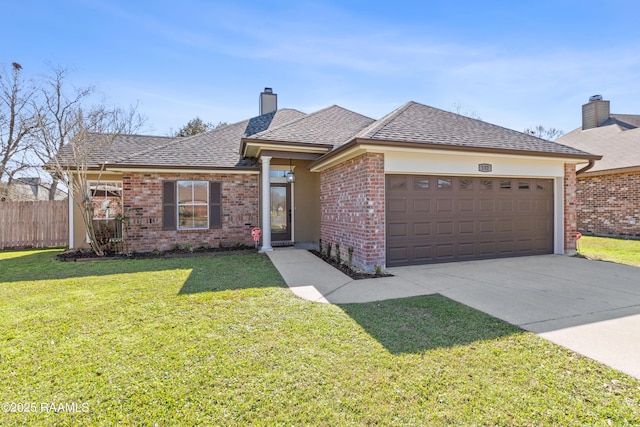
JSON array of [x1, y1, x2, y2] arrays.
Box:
[[33, 66, 94, 200]]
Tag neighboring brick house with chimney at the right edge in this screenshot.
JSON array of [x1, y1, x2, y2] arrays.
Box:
[[557, 95, 640, 237]]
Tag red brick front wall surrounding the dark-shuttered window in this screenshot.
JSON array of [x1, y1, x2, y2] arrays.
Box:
[[122, 173, 259, 251]]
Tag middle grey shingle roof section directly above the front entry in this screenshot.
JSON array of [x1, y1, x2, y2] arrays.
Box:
[[246, 105, 374, 146]]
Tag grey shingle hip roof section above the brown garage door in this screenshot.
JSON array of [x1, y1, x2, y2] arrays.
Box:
[[356, 102, 589, 156]]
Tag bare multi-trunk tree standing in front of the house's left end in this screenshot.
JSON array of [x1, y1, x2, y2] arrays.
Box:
[[46, 106, 145, 256]]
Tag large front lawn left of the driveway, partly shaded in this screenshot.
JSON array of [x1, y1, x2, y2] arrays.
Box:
[[0, 251, 640, 426]]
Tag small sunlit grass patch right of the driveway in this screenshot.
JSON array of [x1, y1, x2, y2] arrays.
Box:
[[578, 236, 640, 267]]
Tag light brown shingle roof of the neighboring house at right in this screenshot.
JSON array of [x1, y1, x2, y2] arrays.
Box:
[[558, 118, 640, 172]]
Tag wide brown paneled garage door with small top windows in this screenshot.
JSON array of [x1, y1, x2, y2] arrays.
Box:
[[386, 175, 553, 267]]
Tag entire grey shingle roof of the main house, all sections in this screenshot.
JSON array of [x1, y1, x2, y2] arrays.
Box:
[[52, 102, 596, 172]]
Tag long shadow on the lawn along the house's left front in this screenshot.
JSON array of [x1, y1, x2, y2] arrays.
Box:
[[0, 249, 286, 294]]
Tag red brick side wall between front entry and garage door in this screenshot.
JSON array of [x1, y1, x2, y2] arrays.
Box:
[[320, 153, 386, 271]]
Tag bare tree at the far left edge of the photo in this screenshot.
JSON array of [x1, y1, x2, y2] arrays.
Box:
[[0, 62, 37, 197]]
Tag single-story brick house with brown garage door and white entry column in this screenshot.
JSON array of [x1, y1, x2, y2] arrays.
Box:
[[56, 88, 599, 270]]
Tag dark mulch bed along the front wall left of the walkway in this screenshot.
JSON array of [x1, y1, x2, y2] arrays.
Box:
[[57, 245, 256, 262]]
